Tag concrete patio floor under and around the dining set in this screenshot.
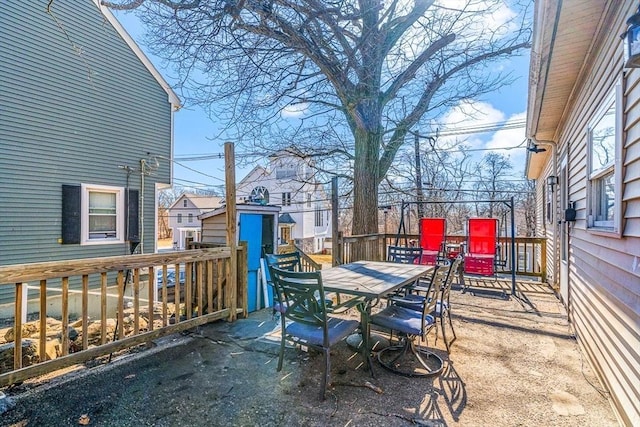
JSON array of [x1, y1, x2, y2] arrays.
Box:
[[0, 281, 619, 426]]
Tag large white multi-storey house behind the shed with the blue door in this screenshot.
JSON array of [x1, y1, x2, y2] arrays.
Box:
[[236, 148, 331, 253]]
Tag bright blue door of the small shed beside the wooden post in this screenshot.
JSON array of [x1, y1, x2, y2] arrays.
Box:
[[239, 214, 262, 312]]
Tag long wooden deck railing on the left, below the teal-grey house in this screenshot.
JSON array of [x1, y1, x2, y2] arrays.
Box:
[[0, 246, 247, 386]]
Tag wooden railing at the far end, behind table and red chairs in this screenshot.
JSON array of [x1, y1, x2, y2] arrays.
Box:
[[334, 234, 547, 281]]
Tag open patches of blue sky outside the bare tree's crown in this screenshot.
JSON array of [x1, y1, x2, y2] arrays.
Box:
[[114, 11, 529, 188]]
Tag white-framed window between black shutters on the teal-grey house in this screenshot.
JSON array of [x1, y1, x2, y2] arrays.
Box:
[[81, 184, 125, 245]]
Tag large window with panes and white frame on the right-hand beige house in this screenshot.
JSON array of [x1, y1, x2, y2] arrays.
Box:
[[587, 85, 622, 232]]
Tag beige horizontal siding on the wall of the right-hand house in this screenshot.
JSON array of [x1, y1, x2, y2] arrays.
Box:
[[538, 2, 640, 426]]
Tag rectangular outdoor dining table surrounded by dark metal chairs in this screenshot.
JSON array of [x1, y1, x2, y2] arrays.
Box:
[[320, 261, 433, 356]]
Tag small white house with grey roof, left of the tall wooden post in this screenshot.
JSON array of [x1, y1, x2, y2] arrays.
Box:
[[168, 193, 223, 249]]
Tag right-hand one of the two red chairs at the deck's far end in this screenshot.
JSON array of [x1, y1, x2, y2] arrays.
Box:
[[464, 218, 498, 276]]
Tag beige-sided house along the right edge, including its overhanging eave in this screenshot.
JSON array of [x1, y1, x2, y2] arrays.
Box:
[[527, 0, 640, 426]]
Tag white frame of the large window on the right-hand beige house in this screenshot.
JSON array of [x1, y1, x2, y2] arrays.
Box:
[[587, 80, 624, 237]]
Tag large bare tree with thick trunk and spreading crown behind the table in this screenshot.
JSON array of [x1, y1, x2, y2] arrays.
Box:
[[103, 0, 530, 234]]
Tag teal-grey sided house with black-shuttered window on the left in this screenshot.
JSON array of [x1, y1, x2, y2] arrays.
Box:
[[0, 0, 180, 303]]
